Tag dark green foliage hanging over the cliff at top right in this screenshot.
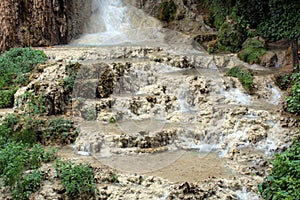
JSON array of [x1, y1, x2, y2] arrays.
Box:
[[206, 0, 300, 70]]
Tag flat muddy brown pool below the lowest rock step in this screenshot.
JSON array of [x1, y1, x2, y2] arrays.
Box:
[[59, 146, 235, 183]]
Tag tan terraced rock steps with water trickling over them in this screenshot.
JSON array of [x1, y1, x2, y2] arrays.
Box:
[[3, 43, 297, 199]]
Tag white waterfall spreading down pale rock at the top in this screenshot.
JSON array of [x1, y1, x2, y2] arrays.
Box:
[[72, 0, 163, 45]]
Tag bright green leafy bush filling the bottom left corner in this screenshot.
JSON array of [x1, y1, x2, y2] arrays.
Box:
[[0, 140, 56, 199]]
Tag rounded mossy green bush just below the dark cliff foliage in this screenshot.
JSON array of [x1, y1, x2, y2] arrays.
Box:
[[238, 37, 266, 64]]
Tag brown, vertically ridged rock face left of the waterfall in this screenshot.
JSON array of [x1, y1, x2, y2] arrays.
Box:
[[0, 0, 91, 52]]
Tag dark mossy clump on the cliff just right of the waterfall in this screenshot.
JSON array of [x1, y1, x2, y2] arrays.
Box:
[[157, 0, 177, 22]]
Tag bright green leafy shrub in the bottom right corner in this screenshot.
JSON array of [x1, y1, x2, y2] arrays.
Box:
[[258, 141, 300, 200]]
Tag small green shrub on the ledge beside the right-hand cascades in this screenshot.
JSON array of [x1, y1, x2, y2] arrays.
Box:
[[226, 66, 254, 94]]
